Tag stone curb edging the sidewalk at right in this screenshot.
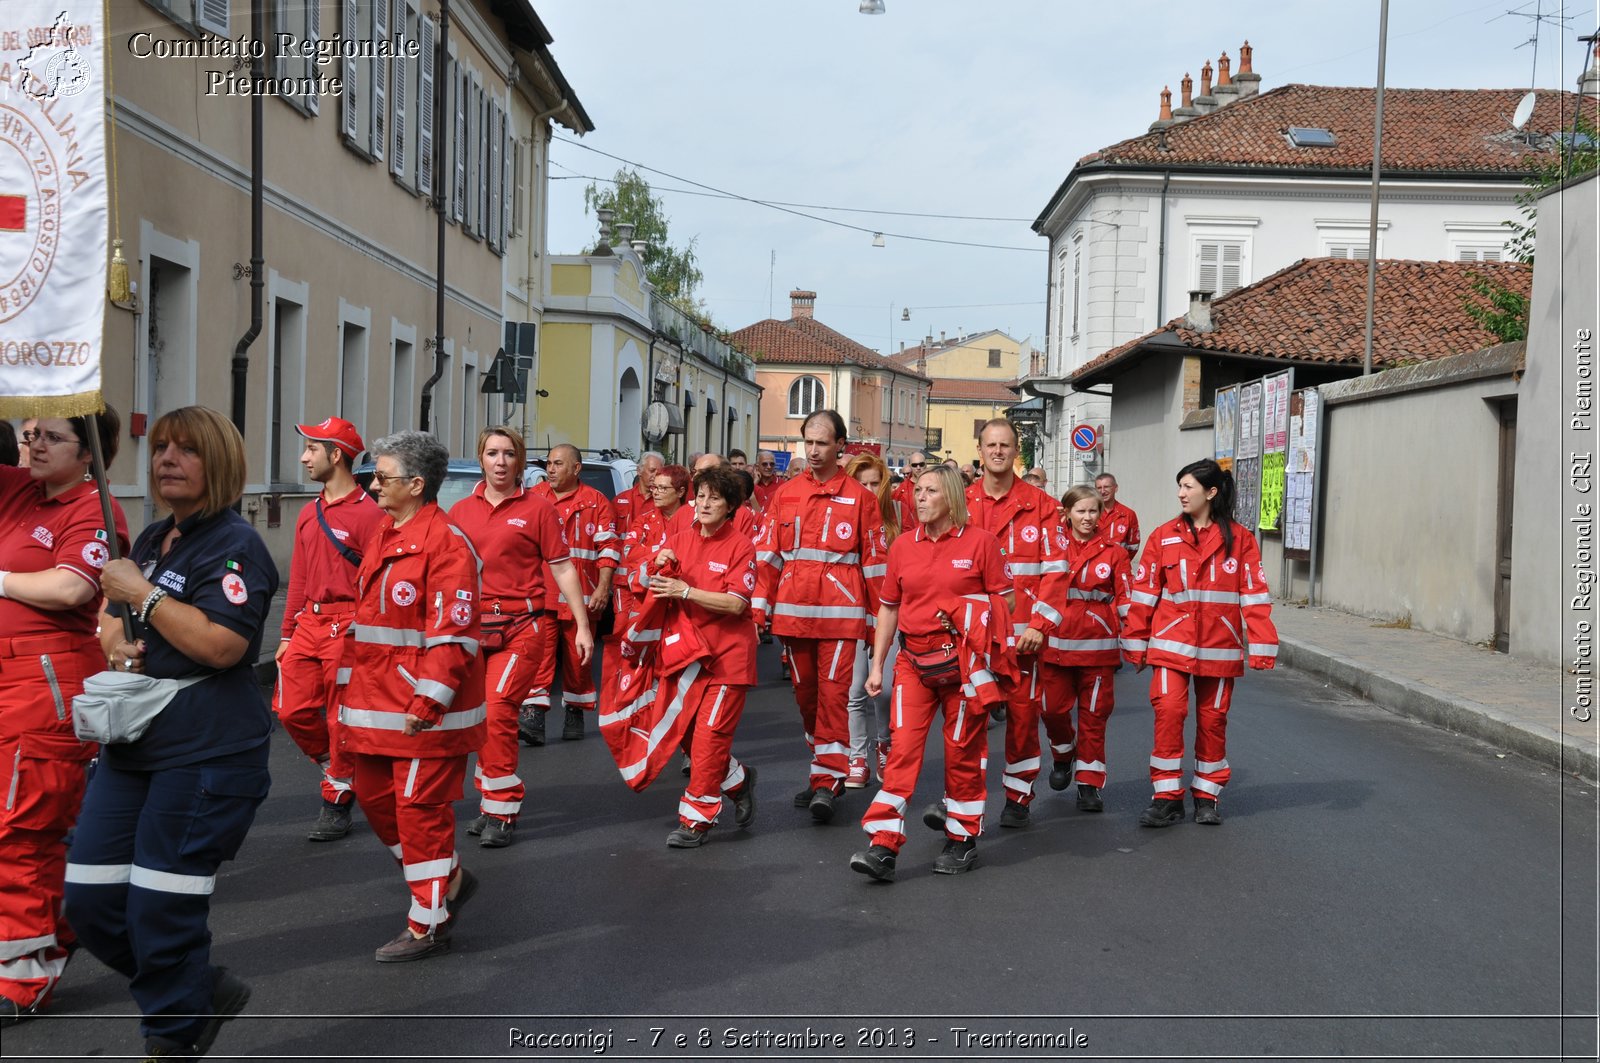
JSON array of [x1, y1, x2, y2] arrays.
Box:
[[1278, 634, 1600, 783]]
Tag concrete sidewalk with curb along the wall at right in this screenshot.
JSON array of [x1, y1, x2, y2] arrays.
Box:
[[1272, 602, 1600, 781]]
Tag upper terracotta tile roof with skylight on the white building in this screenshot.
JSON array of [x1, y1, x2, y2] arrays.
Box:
[[1078, 85, 1574, 173]]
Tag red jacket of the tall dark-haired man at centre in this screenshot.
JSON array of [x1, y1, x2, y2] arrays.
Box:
[[750, 467, 888, 639]]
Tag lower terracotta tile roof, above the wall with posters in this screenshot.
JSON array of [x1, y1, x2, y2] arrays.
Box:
[[1069, 258, 1533, 386]]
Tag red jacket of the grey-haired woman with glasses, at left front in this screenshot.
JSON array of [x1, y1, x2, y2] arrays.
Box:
[[339, 503, 485, 757]]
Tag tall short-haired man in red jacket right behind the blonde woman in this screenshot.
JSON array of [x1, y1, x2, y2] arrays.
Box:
[[966, 418, 1062, 828]]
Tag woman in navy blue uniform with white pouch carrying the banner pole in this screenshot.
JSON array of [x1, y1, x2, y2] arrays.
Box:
[[67, 407, 278, 1058]]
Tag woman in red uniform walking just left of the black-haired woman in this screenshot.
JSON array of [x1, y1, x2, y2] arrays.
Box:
[[1016, 487, 1133, 812]]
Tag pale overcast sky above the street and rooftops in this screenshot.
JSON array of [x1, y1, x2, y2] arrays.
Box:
[[534, 0, 1595, 351]]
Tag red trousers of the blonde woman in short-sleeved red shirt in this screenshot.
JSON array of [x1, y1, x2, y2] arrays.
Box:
[[861, 653, 989, 853]]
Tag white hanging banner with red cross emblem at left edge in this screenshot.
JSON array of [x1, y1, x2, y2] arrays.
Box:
[[0, 0, 109, 418]]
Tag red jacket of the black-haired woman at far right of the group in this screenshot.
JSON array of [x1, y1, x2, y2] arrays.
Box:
[[1122, 517, 1278, 676]]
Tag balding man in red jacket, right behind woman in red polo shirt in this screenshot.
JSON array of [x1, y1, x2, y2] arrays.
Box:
[[520, 443, 622, 746]]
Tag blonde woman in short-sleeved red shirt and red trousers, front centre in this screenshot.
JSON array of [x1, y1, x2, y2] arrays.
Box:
[[850, 467, 1011, 882]]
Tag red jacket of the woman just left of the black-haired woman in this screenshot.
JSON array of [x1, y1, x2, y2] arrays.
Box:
[[1032, 532, 1133, 668]]
